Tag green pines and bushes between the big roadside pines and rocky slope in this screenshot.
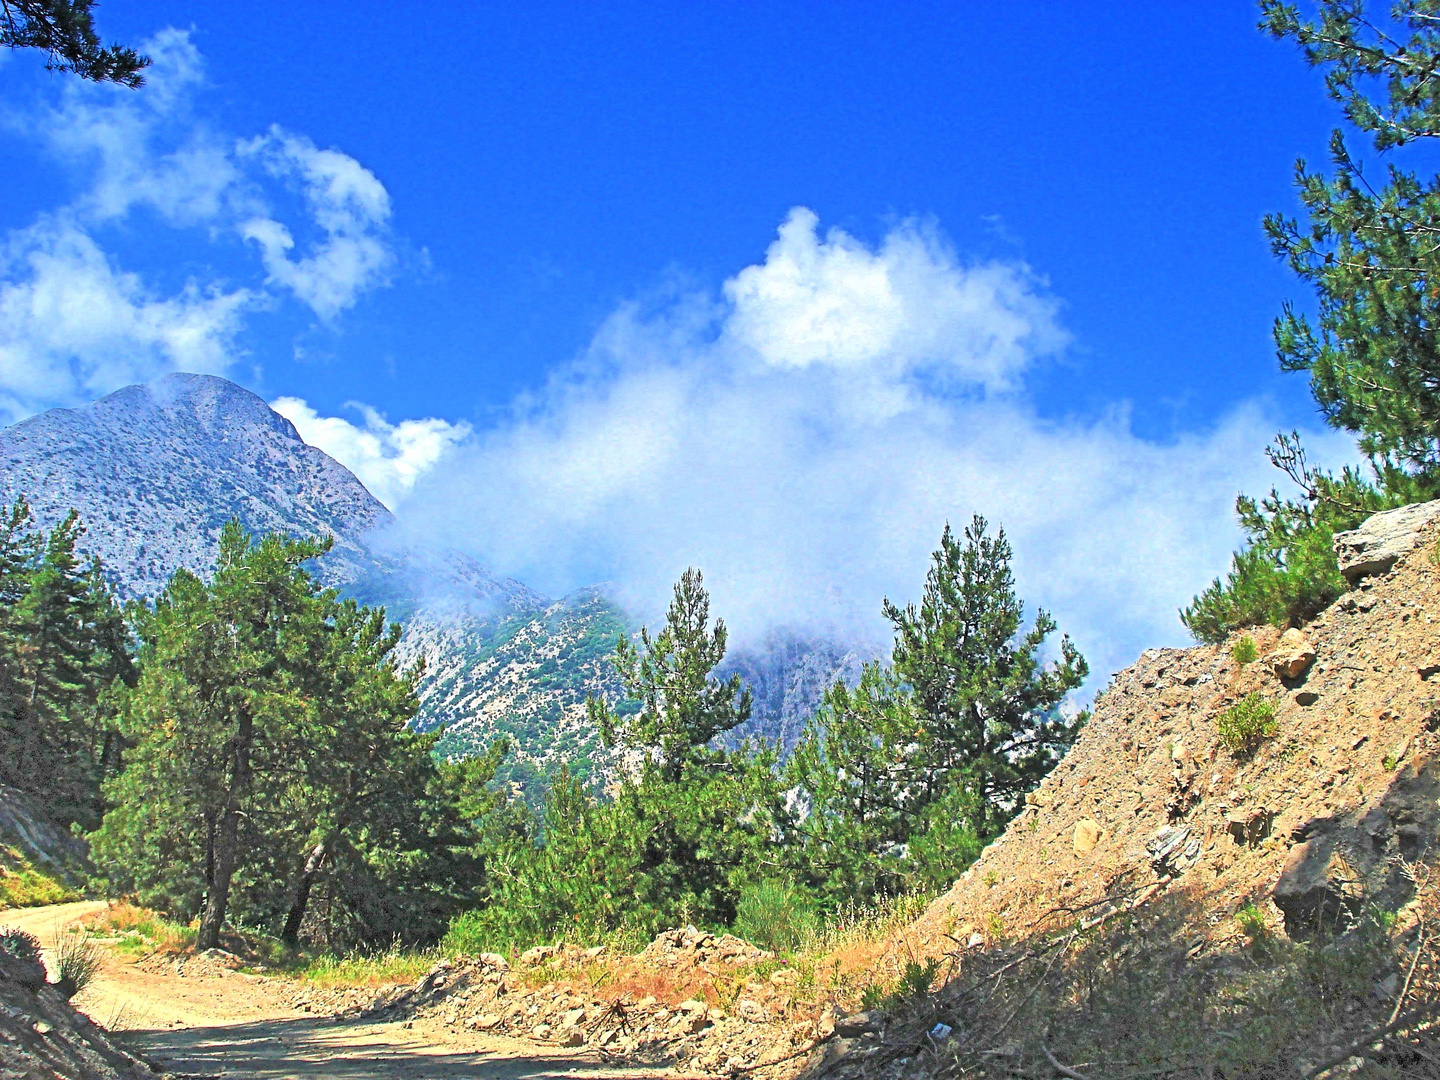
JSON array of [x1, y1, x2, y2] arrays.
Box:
[[449, 518, 1086, 949]]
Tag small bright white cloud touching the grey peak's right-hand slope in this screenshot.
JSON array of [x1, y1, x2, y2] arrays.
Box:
[[271, 397, 471, 510]]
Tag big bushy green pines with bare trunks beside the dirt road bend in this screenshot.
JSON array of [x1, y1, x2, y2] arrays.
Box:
[[92, 523, 494, 948]]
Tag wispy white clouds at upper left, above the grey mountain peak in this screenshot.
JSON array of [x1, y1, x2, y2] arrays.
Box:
[[0, 30, 396, 422]]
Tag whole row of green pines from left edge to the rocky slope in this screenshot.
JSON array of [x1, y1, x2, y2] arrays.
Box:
[[0, 503, 1086, 949]]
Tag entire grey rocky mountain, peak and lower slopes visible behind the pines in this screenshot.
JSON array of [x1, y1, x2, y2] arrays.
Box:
[[0, 374, 858, 780]]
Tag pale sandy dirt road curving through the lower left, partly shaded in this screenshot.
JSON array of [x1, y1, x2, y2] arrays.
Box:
[[0, 901, 677, 1080]]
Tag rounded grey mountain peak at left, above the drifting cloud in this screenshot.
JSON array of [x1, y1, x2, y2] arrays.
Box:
[[0, 373, 392, 596]]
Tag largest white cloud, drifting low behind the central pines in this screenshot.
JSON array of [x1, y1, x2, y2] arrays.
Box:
[[406, 210, 1346, 685]]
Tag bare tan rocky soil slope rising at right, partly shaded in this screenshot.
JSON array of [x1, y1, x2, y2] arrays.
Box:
[[814, 503, 1440, 1076]]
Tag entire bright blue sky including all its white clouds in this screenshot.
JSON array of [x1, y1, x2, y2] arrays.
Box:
[[0, 0, 1345, 676]]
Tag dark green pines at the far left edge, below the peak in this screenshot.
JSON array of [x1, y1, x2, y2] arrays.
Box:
[[0, 500, 134, 828]]
